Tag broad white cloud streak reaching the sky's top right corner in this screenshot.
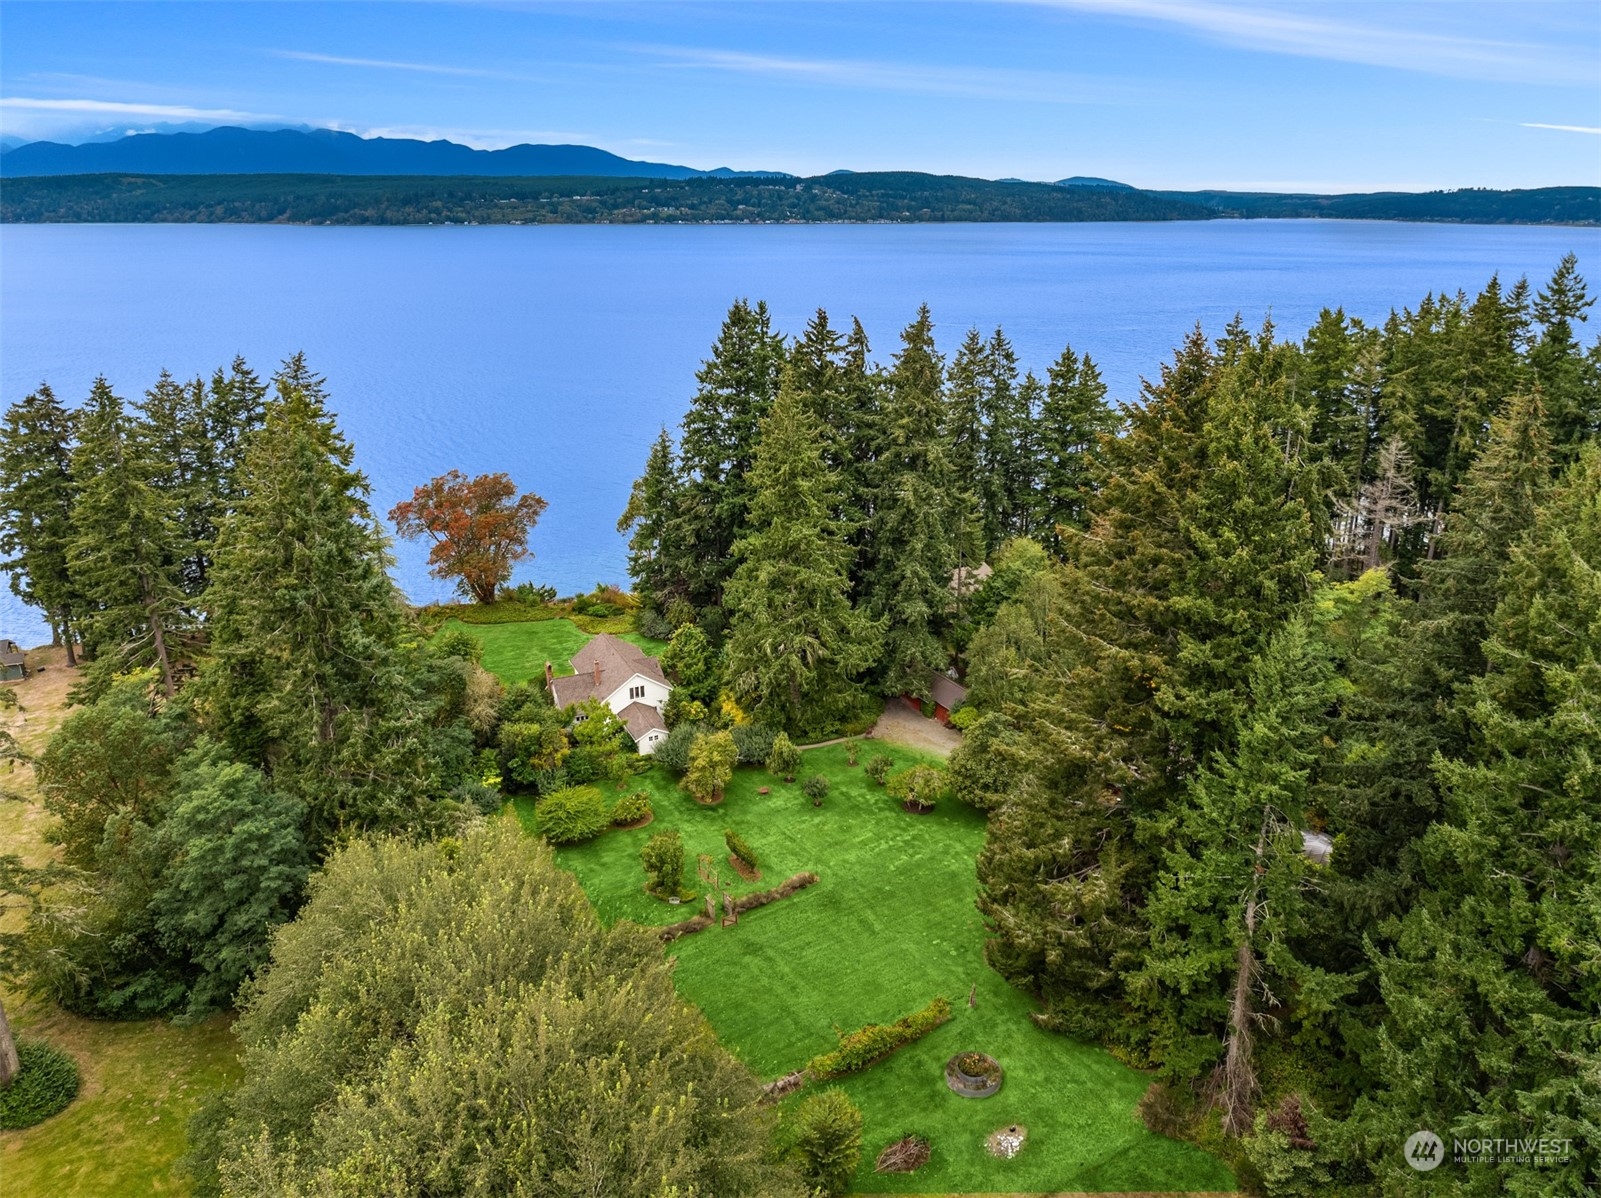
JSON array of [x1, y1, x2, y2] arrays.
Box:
[[1005, 0, 1595, 85]]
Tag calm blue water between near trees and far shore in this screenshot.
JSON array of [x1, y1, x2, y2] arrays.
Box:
[[0, 221, 1601, 642]]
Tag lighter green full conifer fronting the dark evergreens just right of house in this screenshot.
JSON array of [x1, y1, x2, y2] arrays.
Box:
[[727, 383, 877, 732]]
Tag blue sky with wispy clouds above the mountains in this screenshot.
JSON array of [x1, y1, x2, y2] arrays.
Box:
[[0, 0, 1601, 191]]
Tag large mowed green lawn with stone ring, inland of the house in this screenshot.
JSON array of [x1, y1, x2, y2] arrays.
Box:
[[517, 742, 1234, 1193]]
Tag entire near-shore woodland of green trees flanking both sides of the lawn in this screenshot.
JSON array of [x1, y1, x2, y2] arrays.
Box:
[[0, 256, 1601, 1198]]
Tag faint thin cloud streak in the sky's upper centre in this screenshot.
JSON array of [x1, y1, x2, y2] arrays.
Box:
[[624, 45, 1127, 104]]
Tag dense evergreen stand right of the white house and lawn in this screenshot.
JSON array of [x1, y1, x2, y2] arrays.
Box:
[[620, 258, 1601, 1195]]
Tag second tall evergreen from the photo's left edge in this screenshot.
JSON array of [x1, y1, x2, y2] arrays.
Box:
[[69, 378, 189, 697]]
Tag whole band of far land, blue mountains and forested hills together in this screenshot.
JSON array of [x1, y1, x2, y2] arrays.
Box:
[[0, 127, 1601, 224]]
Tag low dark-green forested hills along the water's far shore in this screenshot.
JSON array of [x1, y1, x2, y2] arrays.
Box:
[[0, 171, 1601, 224]]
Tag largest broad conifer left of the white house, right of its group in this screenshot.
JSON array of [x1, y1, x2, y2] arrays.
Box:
[[203, 359, 434, 844]]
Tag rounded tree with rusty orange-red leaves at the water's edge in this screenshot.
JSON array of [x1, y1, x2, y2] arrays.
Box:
[[389, 469, 548, 604]]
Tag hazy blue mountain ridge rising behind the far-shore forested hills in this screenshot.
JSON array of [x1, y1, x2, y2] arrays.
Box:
[[0, 127, 783, 179]]
